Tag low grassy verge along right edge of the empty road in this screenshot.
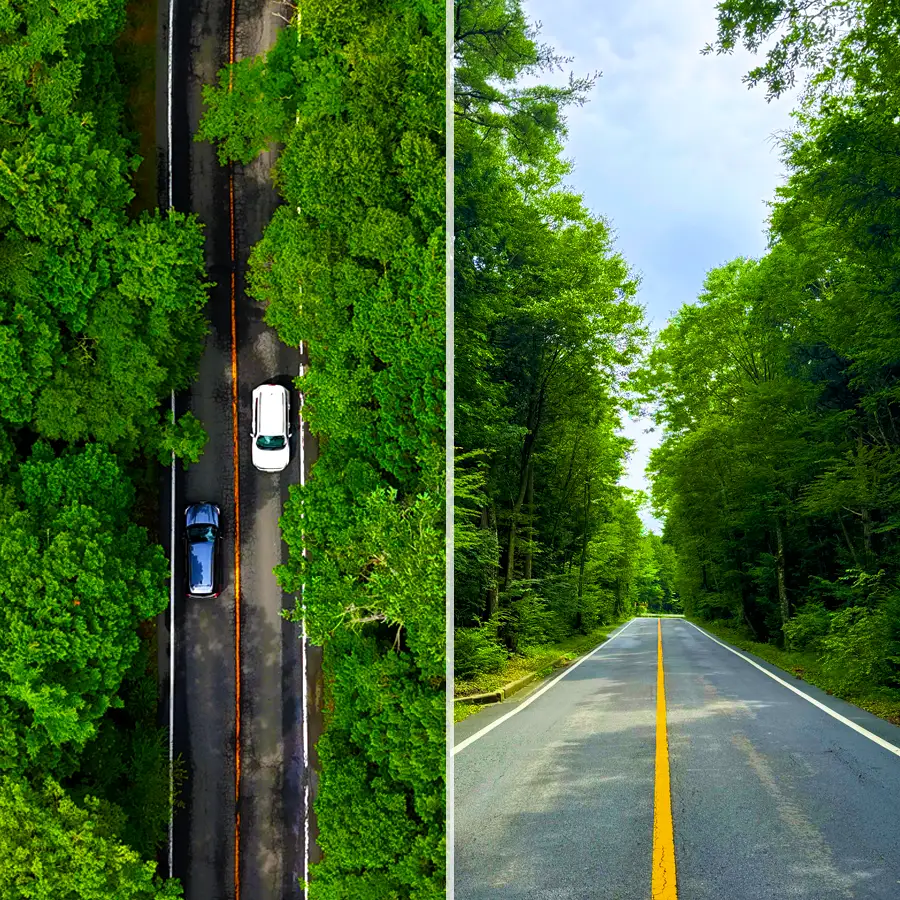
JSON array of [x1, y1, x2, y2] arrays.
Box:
[[687, 617, 900, 725]]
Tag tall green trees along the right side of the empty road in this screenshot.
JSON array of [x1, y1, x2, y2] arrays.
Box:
[[645, 0, 900, 716]]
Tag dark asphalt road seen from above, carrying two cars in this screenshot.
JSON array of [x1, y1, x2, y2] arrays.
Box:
[[157, 0, 321, 900]]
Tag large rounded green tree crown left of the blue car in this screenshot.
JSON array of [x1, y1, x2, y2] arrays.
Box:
[[0, 443, 168, 773]]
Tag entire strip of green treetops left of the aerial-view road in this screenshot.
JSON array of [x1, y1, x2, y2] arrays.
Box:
[[0, 0, 206, 900]]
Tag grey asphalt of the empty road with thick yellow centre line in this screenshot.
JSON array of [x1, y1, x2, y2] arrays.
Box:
[[454, 619, 900, 900]]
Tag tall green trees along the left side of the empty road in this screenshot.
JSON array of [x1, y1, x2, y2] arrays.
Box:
[[454, 0, 678, 680]]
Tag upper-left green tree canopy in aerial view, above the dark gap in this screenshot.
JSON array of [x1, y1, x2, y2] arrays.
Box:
[[0, 0, 206, 454]]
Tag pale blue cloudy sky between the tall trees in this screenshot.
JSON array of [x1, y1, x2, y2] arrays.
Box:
[[523, 0, 796, 531]]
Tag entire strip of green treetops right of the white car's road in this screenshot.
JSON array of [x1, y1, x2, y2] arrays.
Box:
[[197, 0, 446, 900]]
